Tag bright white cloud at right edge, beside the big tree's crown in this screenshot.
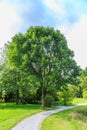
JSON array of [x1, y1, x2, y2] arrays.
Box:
[[65, 14, 87, 68]]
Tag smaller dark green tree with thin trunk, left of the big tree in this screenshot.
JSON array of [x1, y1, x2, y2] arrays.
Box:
[[0, 68, 20, 104]]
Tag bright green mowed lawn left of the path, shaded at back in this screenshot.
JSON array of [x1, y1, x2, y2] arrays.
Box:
[[0, 103, 42, 130]]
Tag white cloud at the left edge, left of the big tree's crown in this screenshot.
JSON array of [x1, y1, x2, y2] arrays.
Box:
[[0, 3, 20, 47]]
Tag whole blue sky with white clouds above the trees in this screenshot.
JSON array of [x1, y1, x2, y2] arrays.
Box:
[[0, 0, 87, 68]]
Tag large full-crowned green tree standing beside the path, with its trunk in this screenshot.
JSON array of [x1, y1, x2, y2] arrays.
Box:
[[8, 26, 78, 108]]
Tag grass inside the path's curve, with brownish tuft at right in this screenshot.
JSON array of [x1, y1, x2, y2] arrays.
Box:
[[41, 106, 87, 130]]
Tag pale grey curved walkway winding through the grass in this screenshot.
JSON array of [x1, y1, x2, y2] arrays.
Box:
[[11, 104, 85, 130]]
